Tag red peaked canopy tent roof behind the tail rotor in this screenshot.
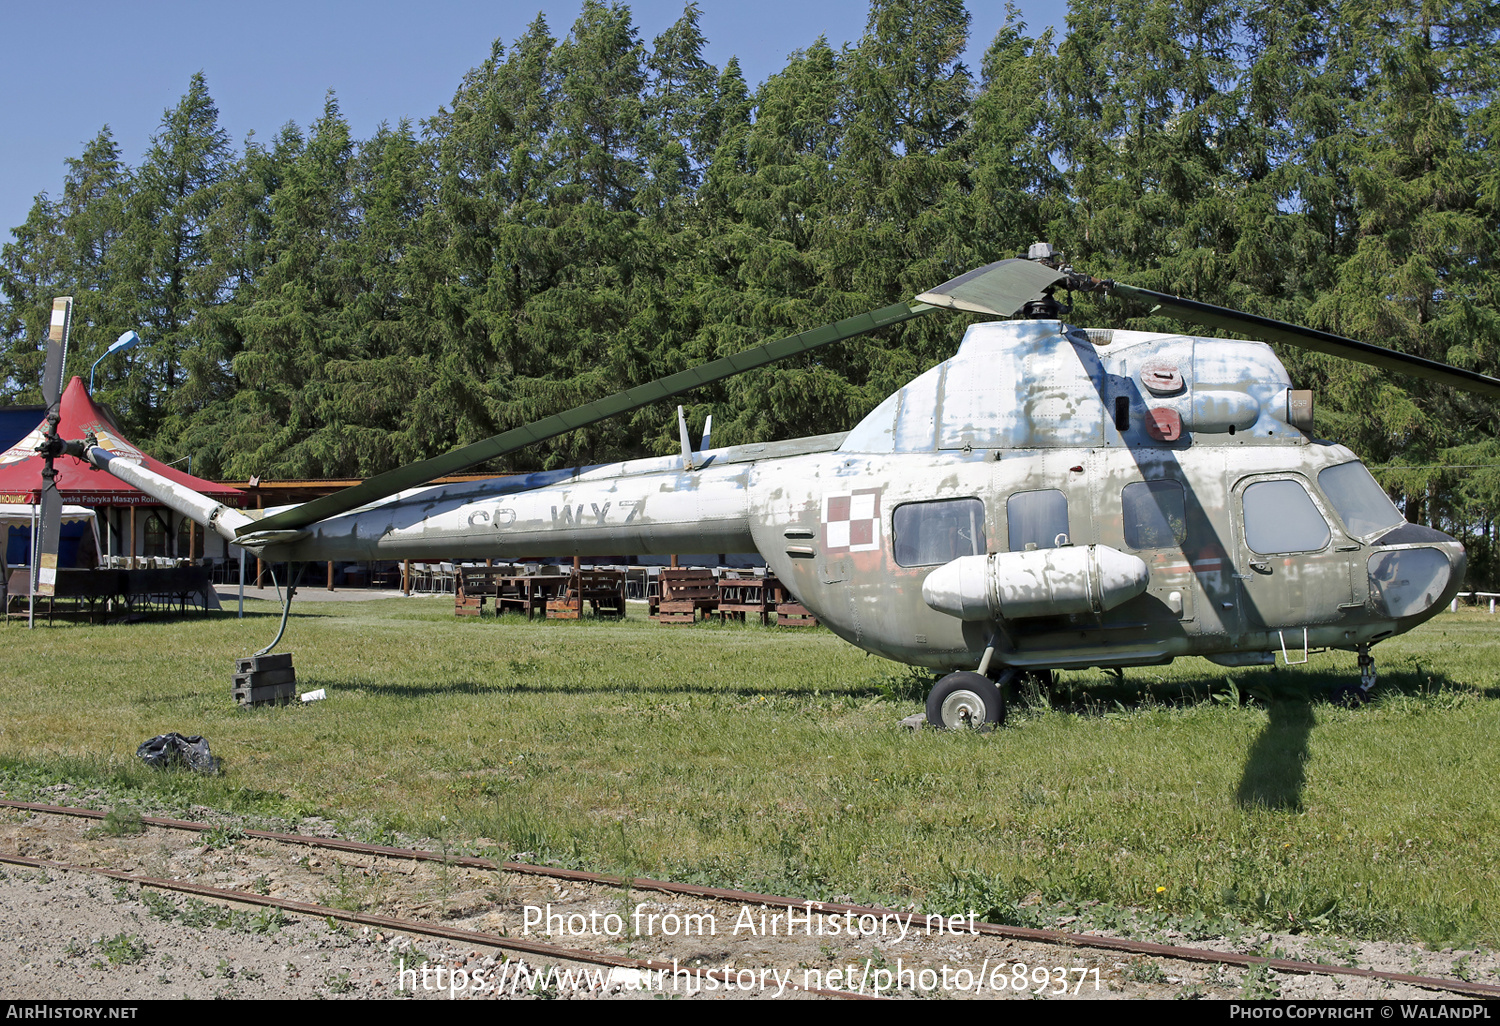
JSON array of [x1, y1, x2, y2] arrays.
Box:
[[0, 377, 246, 506]]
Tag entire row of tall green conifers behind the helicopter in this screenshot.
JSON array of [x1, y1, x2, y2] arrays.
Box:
[[0, 0, 1500, 581]]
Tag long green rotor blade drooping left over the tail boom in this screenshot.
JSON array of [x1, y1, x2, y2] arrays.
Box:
[[247, 303, 933, 536]]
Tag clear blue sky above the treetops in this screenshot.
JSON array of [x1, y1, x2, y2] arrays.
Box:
[[0, 0, 1067, 240]]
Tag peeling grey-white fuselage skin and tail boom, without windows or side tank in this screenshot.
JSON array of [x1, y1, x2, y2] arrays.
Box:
[[267, 321, 1463, 669]]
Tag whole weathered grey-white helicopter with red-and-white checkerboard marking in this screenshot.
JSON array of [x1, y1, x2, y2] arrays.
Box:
[[39, 250, 1500, 729]]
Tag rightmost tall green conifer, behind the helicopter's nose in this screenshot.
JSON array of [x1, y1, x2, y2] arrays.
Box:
[[1311, 0, 1500, 530]]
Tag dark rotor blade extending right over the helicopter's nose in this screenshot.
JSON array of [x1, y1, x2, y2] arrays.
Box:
[[1109, 282, 1500, 399]]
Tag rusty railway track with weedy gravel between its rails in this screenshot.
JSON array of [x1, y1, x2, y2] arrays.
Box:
[[0, 801, 1500, 999]]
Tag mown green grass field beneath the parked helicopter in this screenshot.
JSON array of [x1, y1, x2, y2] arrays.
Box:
[[0, 600, 1500, 945]]
